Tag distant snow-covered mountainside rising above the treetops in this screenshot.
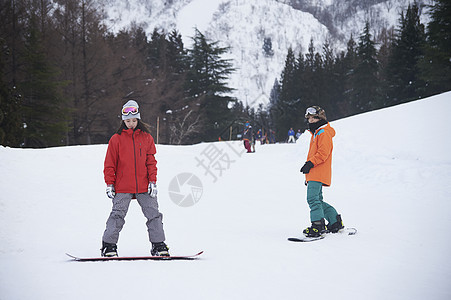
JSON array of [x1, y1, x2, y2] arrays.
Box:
[[98, 0, 432, 107]]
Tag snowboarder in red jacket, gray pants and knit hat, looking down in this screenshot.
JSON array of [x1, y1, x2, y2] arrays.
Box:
[[101, 100, 169, 257]]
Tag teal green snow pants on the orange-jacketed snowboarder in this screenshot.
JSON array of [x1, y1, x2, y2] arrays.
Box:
[[307, 181, 338, 224]]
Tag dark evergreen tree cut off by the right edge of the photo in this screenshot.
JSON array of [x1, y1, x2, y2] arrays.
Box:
[[420, 0, 451, 95]]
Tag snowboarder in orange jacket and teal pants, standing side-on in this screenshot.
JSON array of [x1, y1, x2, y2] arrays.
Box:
[[301, 106, 344, 237]]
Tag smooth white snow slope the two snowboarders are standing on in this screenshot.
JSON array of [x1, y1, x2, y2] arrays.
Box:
[[0, 92, 451, 300]]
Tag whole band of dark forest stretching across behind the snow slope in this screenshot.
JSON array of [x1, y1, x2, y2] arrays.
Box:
[[0, 0, 451, 147]]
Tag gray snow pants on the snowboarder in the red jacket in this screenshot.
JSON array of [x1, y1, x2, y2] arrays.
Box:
[[103, 193, 165, 244]]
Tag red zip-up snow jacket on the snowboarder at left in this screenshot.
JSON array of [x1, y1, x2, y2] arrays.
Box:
[[103, 129, 157, 193]]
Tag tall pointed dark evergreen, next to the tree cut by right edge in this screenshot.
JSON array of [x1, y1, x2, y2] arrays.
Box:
[[387, 3, 425, 104]]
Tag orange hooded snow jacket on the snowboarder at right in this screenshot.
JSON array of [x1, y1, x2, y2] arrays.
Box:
[[305, 123, 335, 186]]
